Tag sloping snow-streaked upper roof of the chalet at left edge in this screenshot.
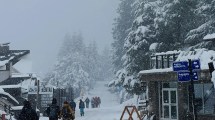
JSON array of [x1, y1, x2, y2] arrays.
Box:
[[0, 50, 30, 67]]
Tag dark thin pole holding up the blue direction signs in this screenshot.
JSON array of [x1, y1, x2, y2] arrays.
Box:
[[188, 59, 197, 120]]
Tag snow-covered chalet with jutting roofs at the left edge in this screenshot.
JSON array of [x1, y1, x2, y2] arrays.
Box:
[[0, 43, 31, 111]]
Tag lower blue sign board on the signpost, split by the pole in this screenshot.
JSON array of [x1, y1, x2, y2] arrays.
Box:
[[178, 71, 198, 82]]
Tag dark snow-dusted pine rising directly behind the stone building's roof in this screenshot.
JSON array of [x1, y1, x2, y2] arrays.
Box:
[[155, 0, 197, 52]]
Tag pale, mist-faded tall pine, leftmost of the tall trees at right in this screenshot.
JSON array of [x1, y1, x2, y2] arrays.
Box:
[[112, 0, 135, 71]]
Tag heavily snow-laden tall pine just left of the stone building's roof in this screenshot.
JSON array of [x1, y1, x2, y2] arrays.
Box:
[[123, 0, 157, 94]]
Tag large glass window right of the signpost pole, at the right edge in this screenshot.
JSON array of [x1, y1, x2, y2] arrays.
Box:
[[194, 83, 215, 114]]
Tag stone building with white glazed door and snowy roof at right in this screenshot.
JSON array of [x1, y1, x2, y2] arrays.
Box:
[[139, 49, 215, 120]]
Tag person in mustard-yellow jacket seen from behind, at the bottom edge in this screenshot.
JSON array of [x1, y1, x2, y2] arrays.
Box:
[[61, 101, 75, 120]]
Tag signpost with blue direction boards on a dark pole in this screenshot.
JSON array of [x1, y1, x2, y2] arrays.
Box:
[[173, 59, 201, 120]]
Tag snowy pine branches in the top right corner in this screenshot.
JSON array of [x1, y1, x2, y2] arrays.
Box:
[[185, 0, 215, 50]]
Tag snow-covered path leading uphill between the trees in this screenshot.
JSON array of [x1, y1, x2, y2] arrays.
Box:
[[40, 81, 127, 120]]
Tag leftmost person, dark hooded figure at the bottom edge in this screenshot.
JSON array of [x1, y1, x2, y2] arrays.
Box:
[[18, 100, 39, 120]]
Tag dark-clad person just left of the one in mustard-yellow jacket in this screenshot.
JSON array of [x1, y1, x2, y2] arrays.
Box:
[[46, 98, 60, 120]]
